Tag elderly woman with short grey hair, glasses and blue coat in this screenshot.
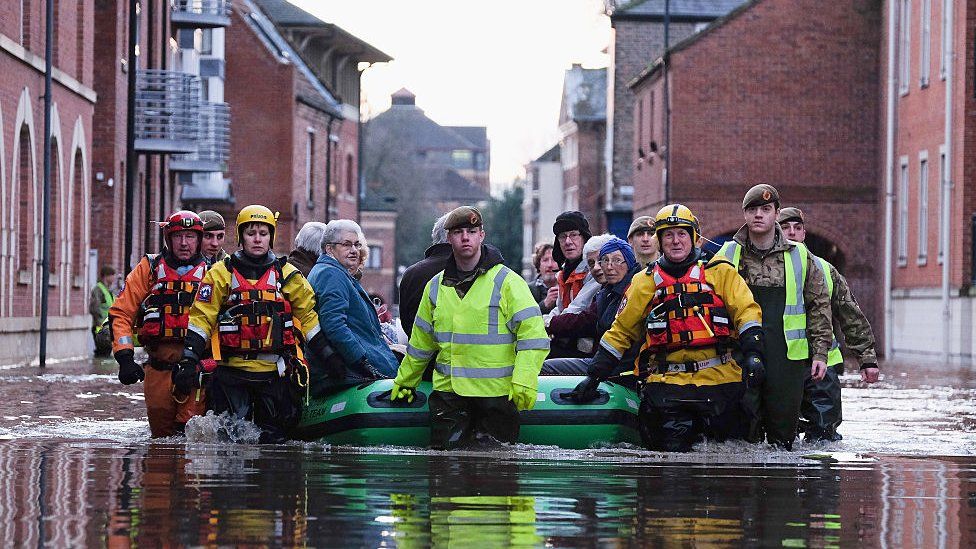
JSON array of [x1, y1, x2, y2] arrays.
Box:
[[308, 219, 397, 386]]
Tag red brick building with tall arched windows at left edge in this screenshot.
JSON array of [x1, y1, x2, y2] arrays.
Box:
[[0, 0, 98, 364]]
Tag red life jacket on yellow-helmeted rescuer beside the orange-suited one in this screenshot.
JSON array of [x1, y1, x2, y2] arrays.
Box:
[[218, 256, 298, 356]]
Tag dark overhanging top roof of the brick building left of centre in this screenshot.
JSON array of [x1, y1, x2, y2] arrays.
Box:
[[253, 0, 393, 63]]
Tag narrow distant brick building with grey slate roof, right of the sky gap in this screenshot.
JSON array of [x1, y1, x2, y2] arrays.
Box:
[[559, 65, 608, 234]]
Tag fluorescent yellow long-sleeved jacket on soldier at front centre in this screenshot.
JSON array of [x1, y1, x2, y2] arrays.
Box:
[[397, 265, 549, 397]]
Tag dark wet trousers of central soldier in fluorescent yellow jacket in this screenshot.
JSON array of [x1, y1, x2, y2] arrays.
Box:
[[427, 391, 519, 450]]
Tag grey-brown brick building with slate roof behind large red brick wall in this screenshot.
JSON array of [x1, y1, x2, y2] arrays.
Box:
[[604, 0, 743, 234]]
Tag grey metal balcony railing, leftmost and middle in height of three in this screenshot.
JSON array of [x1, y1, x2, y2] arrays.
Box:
[[135, 69, 200, 153]]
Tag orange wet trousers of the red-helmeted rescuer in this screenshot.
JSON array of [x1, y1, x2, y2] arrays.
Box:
[[143, 364, 207, 438]]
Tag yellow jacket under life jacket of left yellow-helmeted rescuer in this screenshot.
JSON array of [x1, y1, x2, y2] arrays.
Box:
[[188, 252, 319, 372]]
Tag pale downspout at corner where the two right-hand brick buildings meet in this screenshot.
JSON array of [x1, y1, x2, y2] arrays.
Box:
[[884, 0, 898, 360]]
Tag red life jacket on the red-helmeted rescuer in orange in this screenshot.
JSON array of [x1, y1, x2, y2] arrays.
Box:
[[138, 254, 207, 344]]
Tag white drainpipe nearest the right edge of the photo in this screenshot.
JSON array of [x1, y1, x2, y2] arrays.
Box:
[[939, 0, 955, 363]]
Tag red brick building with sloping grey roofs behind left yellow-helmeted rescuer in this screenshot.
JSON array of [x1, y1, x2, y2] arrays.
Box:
[[222, 0, 390, 252]]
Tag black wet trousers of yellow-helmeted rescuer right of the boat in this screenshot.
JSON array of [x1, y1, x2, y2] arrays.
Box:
[[637, 382, 749, 452]]
